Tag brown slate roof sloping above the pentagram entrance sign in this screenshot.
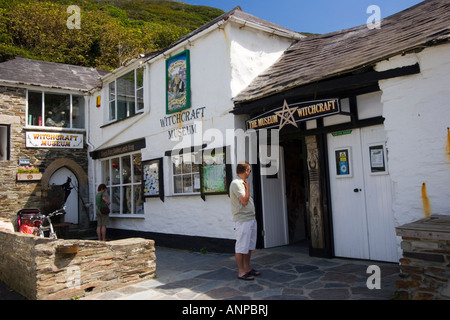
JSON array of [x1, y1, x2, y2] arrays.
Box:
[[233, 0, 450, 105]]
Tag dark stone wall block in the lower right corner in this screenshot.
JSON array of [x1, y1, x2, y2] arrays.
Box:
[[396, 216, 450, 300]]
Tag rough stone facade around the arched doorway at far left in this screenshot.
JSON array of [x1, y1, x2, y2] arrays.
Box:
[[0, 86, 88, 217]]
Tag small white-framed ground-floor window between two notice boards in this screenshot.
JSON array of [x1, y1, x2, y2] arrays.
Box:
[[172, 152, 201, 194]]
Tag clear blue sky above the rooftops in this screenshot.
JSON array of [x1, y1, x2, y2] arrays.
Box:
[[178, 0, 422, 33]]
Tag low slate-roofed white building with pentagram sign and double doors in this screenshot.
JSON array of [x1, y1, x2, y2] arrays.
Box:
[[233, 0, 450, 261]]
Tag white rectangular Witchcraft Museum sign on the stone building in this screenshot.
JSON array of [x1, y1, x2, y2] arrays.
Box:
[[25, 131, 83, 149]]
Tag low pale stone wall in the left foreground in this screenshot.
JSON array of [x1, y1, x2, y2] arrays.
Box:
[[0, 218, 156, 300]]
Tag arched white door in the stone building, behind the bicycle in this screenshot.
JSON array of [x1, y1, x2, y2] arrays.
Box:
[[49, 167, 78, 224]]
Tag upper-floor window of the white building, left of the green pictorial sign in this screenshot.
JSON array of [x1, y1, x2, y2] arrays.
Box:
[[108, 68, 144, 121]]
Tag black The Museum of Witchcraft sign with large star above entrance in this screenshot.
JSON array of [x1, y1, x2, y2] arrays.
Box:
[[246, 99, 341, 130]]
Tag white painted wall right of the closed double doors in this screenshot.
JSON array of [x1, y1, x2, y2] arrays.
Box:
[[377, 44, 450, 226]]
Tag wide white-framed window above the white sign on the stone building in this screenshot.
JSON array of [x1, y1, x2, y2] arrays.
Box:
[[27, 91, 85, 129]]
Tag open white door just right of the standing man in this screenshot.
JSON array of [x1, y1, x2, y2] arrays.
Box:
[[261, 147, 289, 248]]
